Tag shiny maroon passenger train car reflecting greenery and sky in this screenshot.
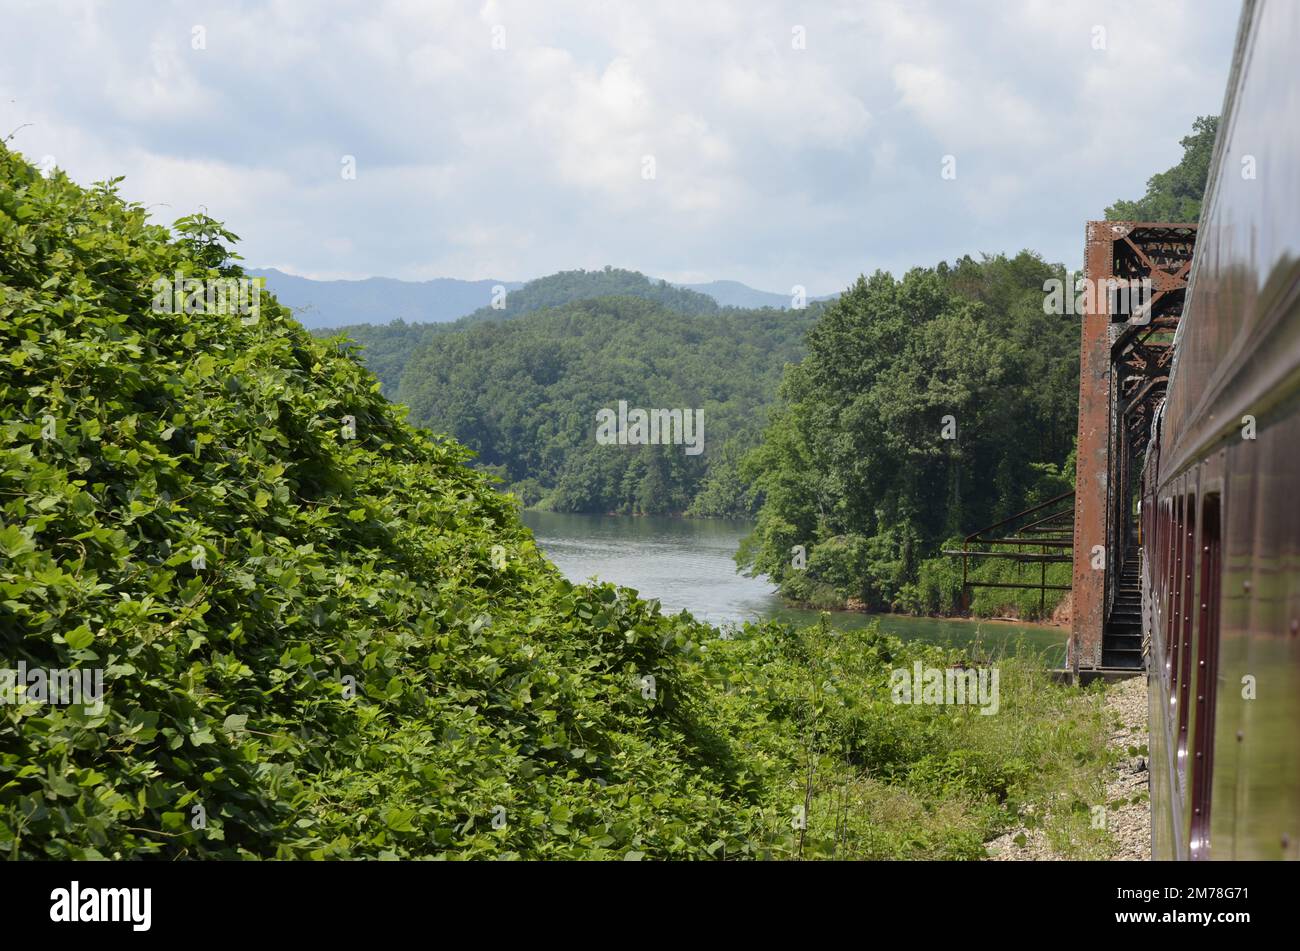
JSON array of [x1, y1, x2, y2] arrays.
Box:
[[1140, 0, 1300, 859]]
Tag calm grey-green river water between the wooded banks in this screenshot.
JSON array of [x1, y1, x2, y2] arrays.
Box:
[[524, 512, 1066, 664]]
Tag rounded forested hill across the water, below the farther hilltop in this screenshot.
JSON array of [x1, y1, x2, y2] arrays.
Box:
[[379, 298, 816, 514]]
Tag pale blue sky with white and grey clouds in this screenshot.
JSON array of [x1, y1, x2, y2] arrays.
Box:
[[0, 0, 1239, 295]]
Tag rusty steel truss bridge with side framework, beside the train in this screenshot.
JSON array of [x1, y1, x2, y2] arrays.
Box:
[[945, 221, 1196, 679]]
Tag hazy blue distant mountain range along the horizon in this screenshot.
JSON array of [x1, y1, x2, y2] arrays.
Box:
[[247, 268, 826, 329]]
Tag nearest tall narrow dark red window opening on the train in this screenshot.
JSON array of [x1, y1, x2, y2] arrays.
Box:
[[1190, 494, 1222, 859]]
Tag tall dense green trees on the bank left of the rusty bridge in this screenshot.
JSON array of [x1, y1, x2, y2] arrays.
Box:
[[738, 252, 1079, 611]]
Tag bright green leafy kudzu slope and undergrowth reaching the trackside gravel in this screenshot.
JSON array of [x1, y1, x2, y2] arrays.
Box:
[[0, 147, 1106, 859]]
